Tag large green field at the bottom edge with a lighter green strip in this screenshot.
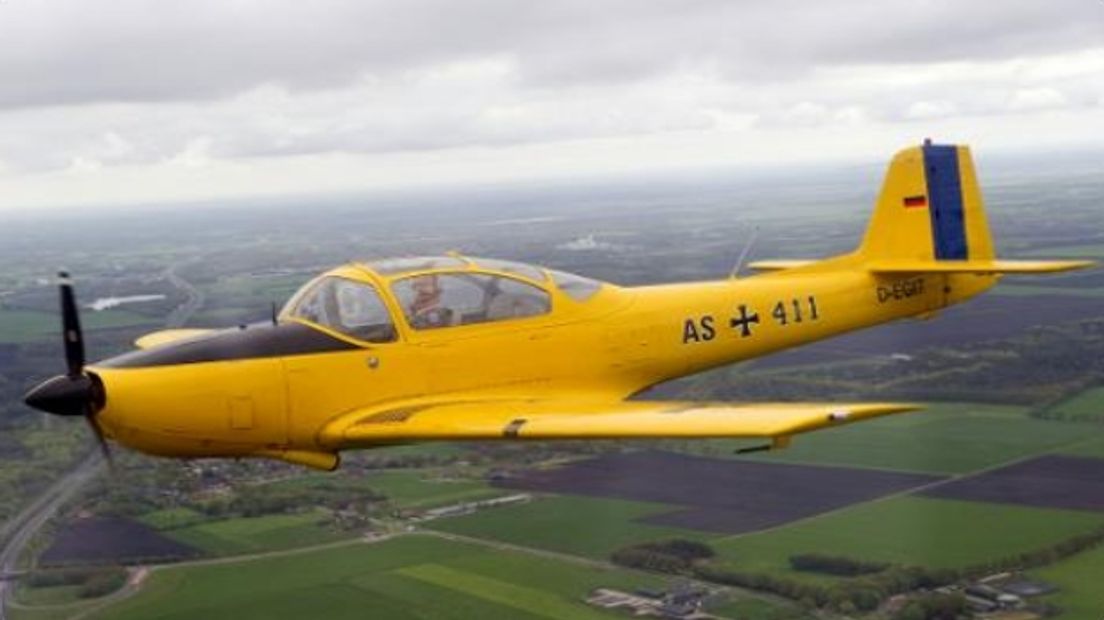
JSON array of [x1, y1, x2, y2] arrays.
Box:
[[88, 536, 786, 620]]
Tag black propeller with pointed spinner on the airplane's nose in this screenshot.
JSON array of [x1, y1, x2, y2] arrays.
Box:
[[23, 271, 112, 463]]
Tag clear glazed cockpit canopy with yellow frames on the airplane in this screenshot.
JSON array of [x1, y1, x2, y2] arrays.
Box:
[[282, 256, 603, 342]]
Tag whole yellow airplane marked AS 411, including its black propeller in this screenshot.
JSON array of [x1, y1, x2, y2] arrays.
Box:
[[25, 141, 1090, 470]]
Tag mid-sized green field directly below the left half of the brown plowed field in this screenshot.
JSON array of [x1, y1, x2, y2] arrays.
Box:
[[426, 495, 711, 559]]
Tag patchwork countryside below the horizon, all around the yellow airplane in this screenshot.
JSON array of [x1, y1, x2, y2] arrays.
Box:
[[0, 152, 1104, 619]]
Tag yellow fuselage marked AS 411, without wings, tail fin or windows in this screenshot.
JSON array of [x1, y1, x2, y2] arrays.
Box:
[[88, 249, 996, 457]]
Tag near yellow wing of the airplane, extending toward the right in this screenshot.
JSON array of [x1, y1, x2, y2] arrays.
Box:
[[320, 400, 919, 450]]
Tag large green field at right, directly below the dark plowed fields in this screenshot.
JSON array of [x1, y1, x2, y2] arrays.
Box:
[[710, 496, 1104, 575]]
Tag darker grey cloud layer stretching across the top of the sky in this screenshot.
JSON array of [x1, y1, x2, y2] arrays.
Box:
[[0, 0, 1104, 107]]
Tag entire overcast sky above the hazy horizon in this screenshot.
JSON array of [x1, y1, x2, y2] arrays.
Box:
[[0, 0, 1104, 209]]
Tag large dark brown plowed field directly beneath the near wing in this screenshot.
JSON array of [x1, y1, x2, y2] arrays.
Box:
[[496, 451, 940, 534]]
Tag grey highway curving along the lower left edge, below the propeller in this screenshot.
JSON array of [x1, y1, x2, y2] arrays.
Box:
[[0, 450, 104, 620]]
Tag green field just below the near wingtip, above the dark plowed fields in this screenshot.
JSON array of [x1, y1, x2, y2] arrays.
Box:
[[682, 404, 1101, 473]]
